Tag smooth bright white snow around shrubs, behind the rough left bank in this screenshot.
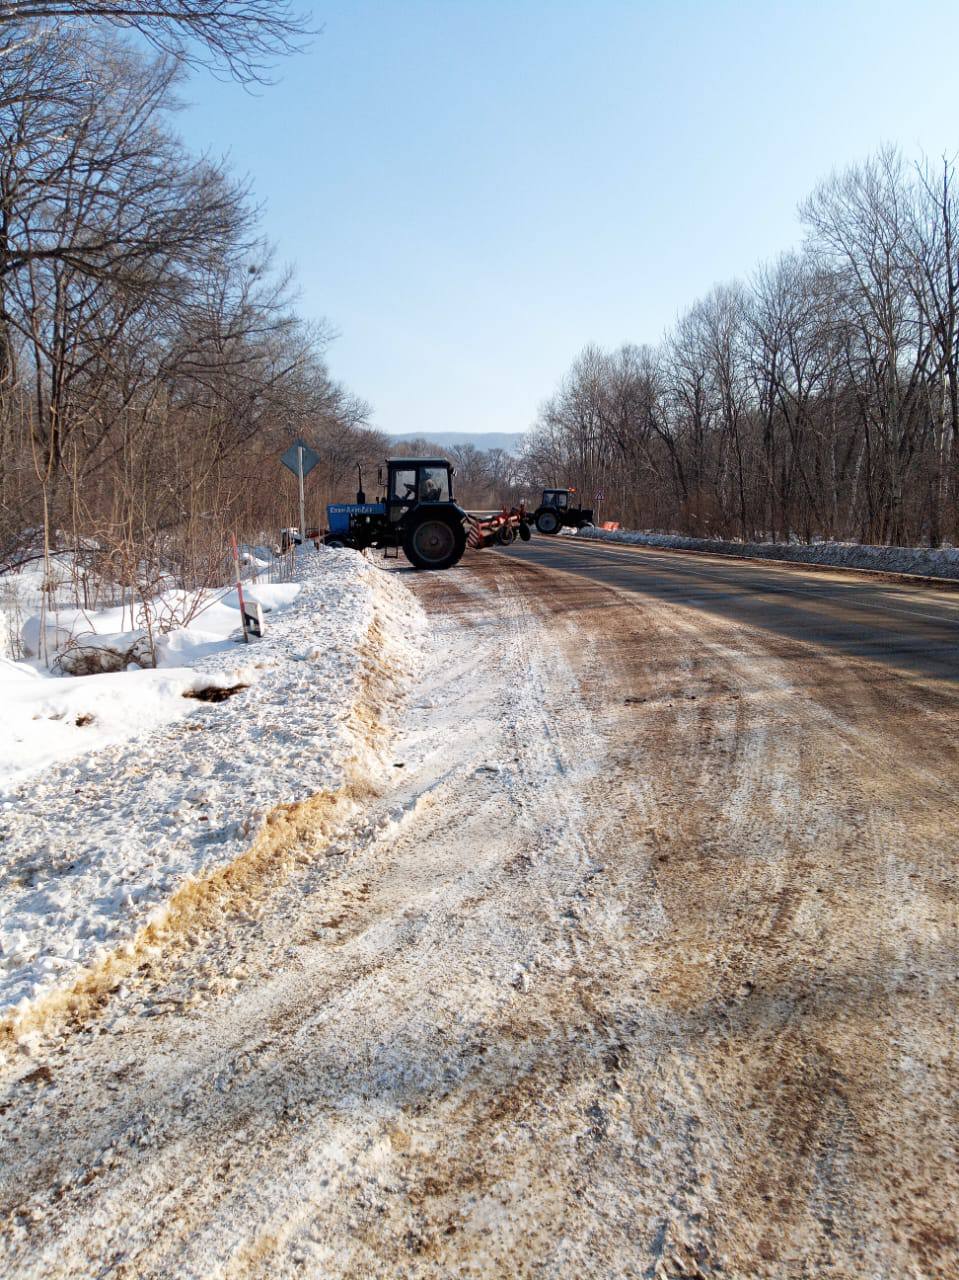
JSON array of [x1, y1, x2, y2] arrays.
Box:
[[0, 582, 300, 794]]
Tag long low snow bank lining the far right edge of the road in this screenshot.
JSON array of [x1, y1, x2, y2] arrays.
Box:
[[577, 529, 959, 579]]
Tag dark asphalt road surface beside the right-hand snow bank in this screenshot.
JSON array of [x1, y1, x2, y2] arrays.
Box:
[[501, 535, 959, 684]]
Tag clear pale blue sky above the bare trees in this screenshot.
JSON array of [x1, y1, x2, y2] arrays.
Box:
[[179, 0, 959, 435]]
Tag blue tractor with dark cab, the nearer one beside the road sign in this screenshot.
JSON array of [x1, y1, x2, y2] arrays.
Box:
[[323, 458, 475, 568]]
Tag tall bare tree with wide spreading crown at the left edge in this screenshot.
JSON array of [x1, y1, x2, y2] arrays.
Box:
[[0, 24, 251, 524]]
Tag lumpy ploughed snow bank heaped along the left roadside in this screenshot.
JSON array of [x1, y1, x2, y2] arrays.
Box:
[[0, 550, 425, 1018]]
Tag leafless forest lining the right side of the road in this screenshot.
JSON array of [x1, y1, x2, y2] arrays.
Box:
[[528, 148, 959, 547]]
